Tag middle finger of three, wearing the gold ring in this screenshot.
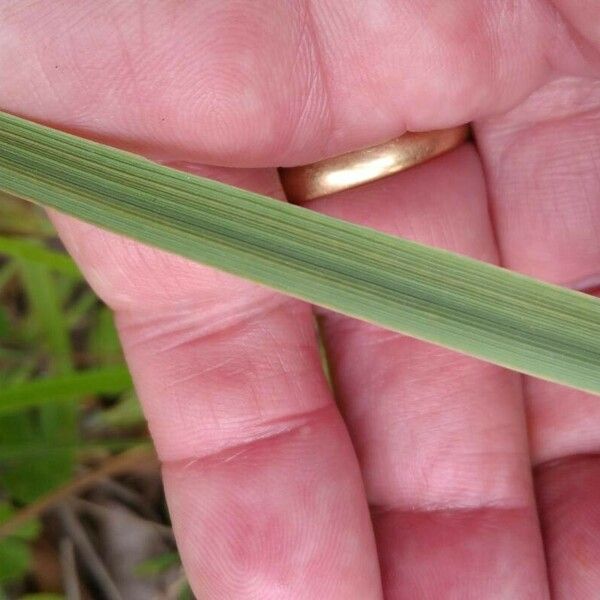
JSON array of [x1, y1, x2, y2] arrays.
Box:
[[304, 145, 547, 598]]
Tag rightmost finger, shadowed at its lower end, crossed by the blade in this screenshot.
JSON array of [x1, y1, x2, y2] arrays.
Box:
[[479, 79, 600, 598]]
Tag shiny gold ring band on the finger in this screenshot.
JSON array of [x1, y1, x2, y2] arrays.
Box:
[[279, 125, 469, 204]]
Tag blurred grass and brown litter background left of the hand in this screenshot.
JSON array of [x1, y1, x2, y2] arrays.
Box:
[[0, 195, 189, 600]]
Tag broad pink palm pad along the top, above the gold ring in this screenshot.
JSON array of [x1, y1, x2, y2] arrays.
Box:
[[0, 0, 584, 166]]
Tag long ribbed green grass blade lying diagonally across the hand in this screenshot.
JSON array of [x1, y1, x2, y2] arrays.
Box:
[[0, 114, 600, 393]]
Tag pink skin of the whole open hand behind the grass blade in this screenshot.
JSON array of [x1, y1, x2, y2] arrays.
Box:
[[0, 0, 600, 600]]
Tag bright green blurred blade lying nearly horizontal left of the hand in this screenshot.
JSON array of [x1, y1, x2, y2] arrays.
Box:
[[0, 365, 132, 414]]
